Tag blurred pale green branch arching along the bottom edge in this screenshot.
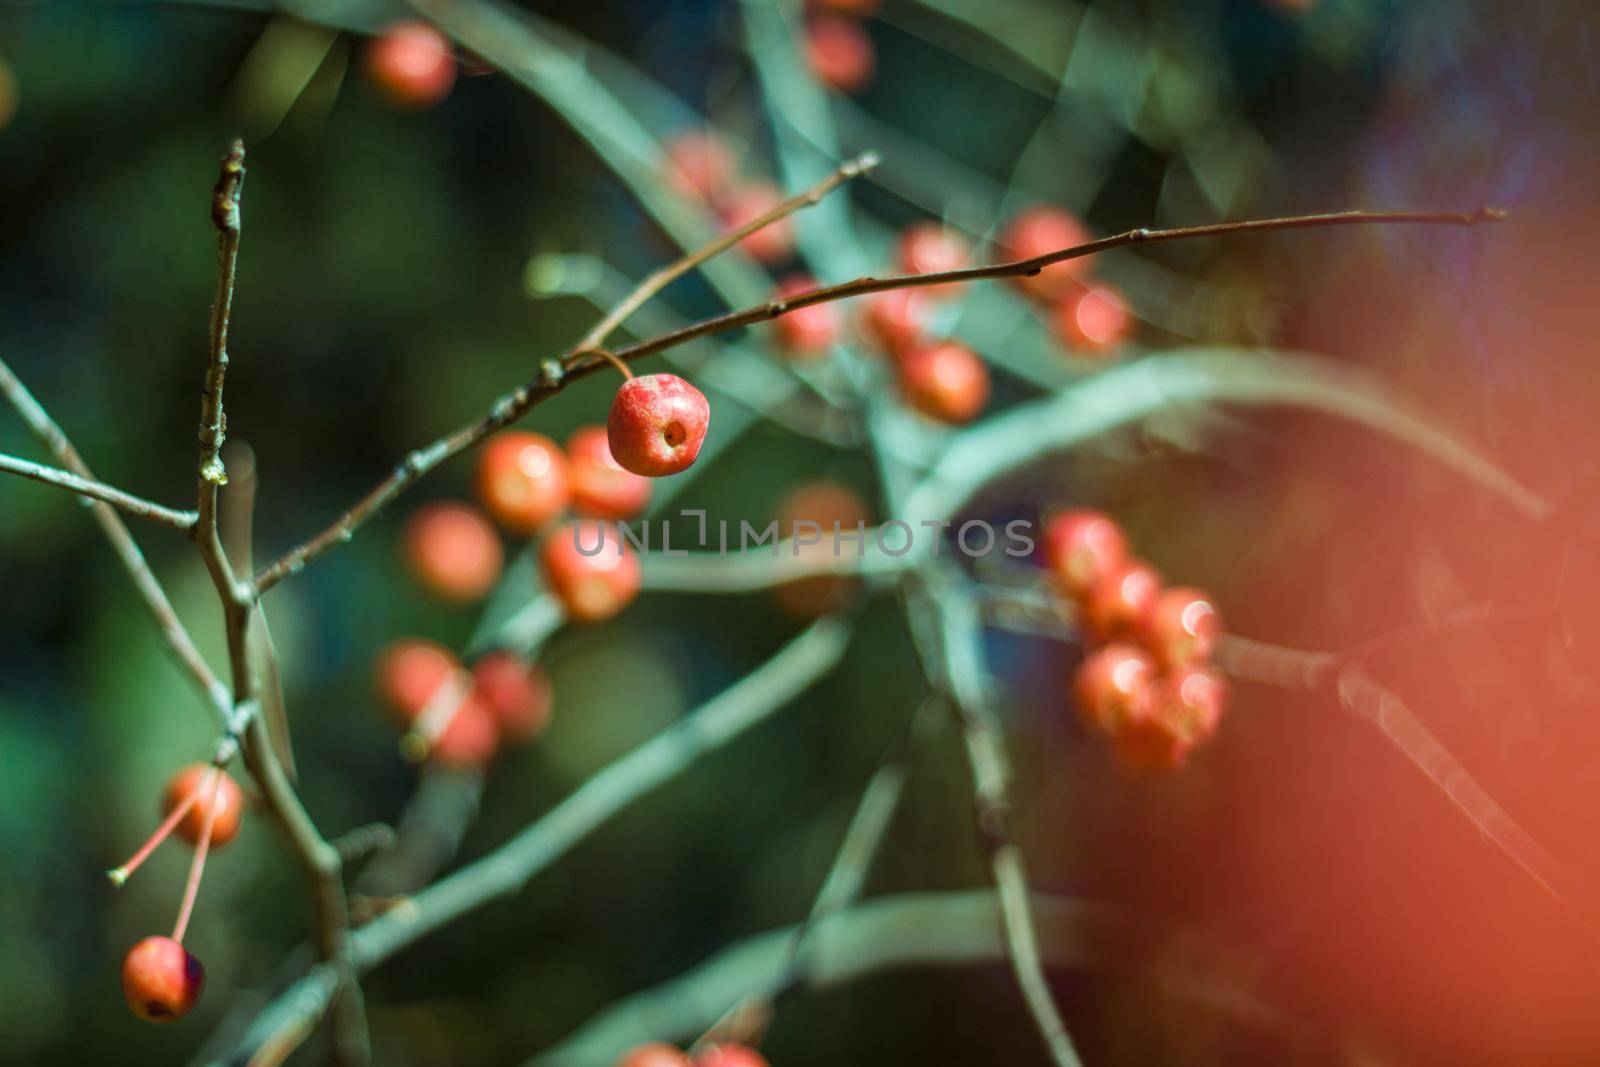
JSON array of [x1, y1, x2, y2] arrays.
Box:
[[528, 889, 1285, 1067]]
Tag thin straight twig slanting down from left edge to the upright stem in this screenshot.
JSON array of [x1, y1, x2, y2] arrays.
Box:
[[0, 360, 234, 726]]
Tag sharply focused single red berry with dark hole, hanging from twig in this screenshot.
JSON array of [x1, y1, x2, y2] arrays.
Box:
[[605, 374, 710, 478]]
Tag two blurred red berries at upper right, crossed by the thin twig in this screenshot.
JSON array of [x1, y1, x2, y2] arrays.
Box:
[[1000, 206, 1133, 355]]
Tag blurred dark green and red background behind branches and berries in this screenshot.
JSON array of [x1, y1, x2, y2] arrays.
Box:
[[0, 0, 1600, 1065]]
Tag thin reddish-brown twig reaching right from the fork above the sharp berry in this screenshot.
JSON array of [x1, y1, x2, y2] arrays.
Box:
[[604, 208, 1506, 367]]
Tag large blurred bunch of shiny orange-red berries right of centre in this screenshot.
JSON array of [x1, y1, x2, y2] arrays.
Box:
[[1045, 510, 1227, 774]]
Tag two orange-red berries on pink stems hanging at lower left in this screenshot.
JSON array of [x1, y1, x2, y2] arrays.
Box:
[[107, 763, 245, 1022]]
